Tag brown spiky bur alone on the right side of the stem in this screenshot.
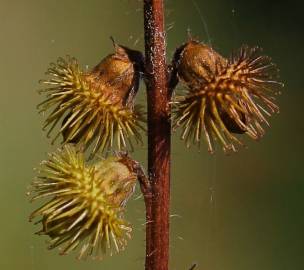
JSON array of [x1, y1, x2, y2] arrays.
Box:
[[173, 40, 282, 152]]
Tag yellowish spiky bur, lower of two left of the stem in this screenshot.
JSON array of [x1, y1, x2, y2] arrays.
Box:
[[29, 144, 137, 259]]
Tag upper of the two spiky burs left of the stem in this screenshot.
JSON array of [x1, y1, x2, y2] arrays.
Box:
[[38, 41, 144, 155]]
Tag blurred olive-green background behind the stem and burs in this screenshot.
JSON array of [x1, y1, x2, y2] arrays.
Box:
[[0, 0, 304, 270]]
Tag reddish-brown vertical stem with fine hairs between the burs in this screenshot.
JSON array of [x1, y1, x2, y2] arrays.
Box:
[[144, 0, 171, 270]]
